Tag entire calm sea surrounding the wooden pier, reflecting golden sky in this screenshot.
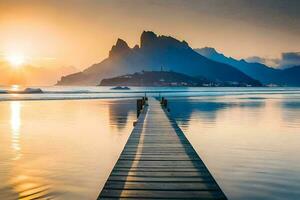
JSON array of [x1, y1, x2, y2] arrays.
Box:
[[0, 87, 300, 200]]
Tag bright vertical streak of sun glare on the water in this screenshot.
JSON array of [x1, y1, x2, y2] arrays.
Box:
[[10, 101, 21, 160]]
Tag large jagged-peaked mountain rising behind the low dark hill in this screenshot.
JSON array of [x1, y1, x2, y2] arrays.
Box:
[[57, 31, 260, 85]]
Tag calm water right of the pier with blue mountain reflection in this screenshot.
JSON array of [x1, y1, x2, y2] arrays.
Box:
[[169, 94, 300, 200]]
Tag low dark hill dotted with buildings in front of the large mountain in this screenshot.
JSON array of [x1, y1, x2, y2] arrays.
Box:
[[100, 71, 215, 87]]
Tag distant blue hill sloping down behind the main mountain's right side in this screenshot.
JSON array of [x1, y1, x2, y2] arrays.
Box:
[[194, 47, 300, 86]]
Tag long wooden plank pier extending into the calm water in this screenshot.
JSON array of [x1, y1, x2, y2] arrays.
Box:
[[98, 99, 226, 199]]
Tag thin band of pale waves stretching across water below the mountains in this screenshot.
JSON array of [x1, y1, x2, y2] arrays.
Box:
[[0, 87, 300, 101]]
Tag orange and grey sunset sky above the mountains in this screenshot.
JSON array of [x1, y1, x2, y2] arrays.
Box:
[[0, 0, 300, 85]]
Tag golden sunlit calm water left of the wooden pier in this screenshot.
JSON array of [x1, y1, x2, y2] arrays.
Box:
[[0, 99, 136, 200]]
